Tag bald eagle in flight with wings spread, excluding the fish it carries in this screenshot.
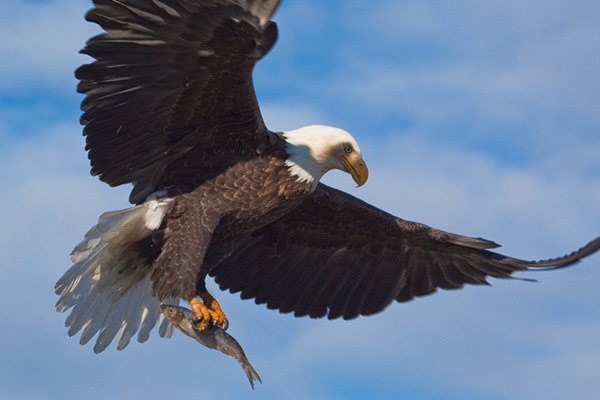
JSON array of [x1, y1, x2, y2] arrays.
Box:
[[55, 0, 600, 352]]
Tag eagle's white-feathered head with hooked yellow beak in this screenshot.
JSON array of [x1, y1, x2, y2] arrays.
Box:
[[283, 125, 369, 189]]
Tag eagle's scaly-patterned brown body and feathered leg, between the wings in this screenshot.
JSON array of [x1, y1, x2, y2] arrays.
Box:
[[150, 140, 310, 300]]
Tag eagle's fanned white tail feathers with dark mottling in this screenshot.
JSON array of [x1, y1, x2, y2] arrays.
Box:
[[55, 198, 179, 353]]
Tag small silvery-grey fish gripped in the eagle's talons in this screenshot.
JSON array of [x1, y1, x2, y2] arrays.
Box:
[[160, 304, 262, 389]]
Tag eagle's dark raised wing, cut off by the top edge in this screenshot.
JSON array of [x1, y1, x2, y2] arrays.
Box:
[[76, 0, 279, 203]]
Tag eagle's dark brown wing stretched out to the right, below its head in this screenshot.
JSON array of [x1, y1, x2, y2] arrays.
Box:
[[210, 184, 600, 319]]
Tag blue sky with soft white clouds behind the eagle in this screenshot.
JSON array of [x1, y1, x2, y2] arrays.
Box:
[[0, 0, 600, 400]]
